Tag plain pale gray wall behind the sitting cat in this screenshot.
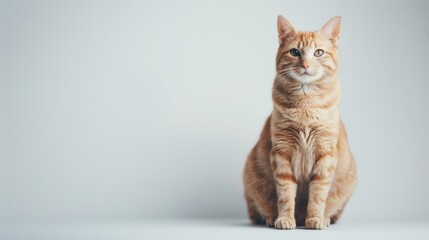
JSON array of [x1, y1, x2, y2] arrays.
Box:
[[0, 0, 429, 221]]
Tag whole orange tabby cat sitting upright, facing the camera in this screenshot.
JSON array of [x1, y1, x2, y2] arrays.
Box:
[[244, 16, 356, 229]]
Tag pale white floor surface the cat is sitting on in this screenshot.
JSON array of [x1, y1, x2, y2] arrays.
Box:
[[0, 219, 429, 240]]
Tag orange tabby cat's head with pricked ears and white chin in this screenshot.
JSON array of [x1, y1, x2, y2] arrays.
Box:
[[276, 16, 341, 83]]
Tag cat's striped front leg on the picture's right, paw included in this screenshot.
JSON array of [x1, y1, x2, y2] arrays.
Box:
[[305, 153, 337, 229]]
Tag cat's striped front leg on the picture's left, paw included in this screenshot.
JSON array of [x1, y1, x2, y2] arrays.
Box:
[[271, 153, 297, 229]]
